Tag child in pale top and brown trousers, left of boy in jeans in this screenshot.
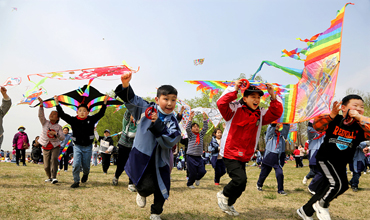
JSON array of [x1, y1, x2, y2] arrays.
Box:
[[38, 97, 65, 184]]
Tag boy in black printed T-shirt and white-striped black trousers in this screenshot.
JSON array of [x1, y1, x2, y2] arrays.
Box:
[[297, 95, 370, 219]]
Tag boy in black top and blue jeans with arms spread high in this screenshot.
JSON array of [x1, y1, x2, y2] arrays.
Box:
[[54, 95, 109, 188]]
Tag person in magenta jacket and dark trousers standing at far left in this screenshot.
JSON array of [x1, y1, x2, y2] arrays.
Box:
[[13, 126, 30, 166]]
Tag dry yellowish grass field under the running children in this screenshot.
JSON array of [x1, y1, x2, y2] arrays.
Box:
[[0, 160, 370, 220]]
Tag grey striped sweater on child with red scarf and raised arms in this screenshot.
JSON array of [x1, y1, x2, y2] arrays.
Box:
[[186, 121, 208, 156]]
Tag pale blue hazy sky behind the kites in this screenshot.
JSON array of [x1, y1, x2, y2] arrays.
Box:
[[0, 0, 370, 150]]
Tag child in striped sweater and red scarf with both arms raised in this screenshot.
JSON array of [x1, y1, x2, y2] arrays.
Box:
[[186, 112, 208, 189]]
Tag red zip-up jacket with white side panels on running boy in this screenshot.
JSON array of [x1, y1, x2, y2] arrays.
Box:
[[217, 86, 283, 162]]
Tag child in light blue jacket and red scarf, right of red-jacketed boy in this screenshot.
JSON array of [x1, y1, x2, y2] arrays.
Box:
[[257, 124, 290, 195]]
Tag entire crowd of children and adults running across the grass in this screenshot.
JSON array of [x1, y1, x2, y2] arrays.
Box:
[[0, 73, 370, 219]]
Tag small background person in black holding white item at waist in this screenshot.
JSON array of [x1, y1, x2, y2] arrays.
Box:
[[94, 129, 114, 174]]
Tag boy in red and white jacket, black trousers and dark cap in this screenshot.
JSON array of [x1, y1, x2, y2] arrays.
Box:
[[217, 80, 283, 216]]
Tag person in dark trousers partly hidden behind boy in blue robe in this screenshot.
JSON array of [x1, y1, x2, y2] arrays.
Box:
[[112, 110, 137, 192]]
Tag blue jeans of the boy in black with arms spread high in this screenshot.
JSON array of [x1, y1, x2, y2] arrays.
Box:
[[72, 144, 92, 182]]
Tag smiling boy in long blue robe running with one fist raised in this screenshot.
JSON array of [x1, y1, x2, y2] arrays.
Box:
[[115, 73, 181, 219]]
